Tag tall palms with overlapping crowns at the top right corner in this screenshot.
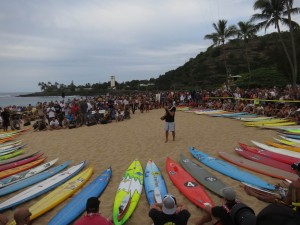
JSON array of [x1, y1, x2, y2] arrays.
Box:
[[251, 0, 300, 87]]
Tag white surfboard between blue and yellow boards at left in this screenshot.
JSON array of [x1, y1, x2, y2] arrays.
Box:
[[0, 161, 85, 212]]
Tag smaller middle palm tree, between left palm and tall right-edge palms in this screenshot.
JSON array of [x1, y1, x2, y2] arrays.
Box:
[[237, 21, 257, 73]]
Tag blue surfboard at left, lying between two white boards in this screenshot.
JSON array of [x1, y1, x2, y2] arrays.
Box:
[[0, 160, 72, 196]]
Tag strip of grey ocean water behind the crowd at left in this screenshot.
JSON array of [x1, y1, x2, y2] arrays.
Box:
[[0, 92, 78, 107]]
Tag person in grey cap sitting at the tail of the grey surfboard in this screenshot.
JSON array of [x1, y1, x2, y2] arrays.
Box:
[[195, 187, 238, 225]]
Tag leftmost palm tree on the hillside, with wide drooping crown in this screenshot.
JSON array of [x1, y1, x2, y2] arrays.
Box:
[[204, 20, 237, 87]]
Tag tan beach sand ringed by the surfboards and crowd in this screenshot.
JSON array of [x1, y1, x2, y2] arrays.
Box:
[[1, 109, 280, 225]]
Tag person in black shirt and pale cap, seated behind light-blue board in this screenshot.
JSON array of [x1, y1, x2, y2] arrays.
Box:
[[149, 194, 191, 225]]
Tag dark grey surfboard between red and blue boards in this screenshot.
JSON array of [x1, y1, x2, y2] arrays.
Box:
[[180, 154, 227, 197]]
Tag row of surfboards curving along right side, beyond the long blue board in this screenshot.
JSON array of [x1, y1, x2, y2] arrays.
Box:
[[180, 109, 300, 197]]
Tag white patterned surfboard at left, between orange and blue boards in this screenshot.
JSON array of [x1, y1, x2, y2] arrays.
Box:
[[0, 158, 58, 188]]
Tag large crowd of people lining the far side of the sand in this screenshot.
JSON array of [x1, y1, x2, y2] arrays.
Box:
[[0, 86, 300, 131]]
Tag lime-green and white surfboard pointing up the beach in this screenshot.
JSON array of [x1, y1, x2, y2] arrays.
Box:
[[113, 160, 144, 225]]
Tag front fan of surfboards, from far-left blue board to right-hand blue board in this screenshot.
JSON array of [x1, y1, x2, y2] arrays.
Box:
[[0, 147, 275, 224]]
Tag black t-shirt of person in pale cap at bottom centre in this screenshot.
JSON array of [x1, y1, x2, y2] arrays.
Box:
[[149, 208, 191, 225]]
